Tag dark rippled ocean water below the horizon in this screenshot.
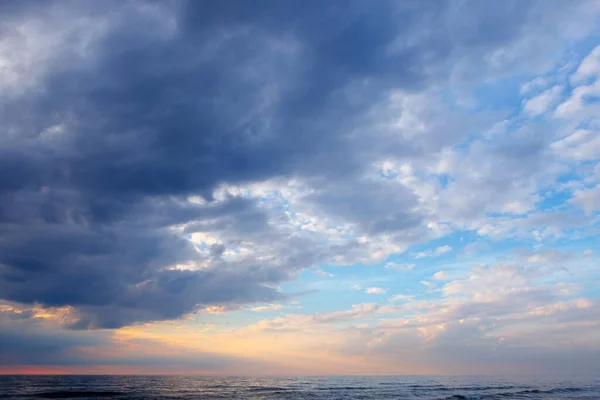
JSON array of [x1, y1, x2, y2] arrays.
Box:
[[0, 375, 600, 400]]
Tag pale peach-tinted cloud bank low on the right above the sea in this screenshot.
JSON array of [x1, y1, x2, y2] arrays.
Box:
[[245, 252, 600, 370]]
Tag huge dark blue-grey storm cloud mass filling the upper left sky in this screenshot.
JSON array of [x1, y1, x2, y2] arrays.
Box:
[[0, 1, 544, 328]]
